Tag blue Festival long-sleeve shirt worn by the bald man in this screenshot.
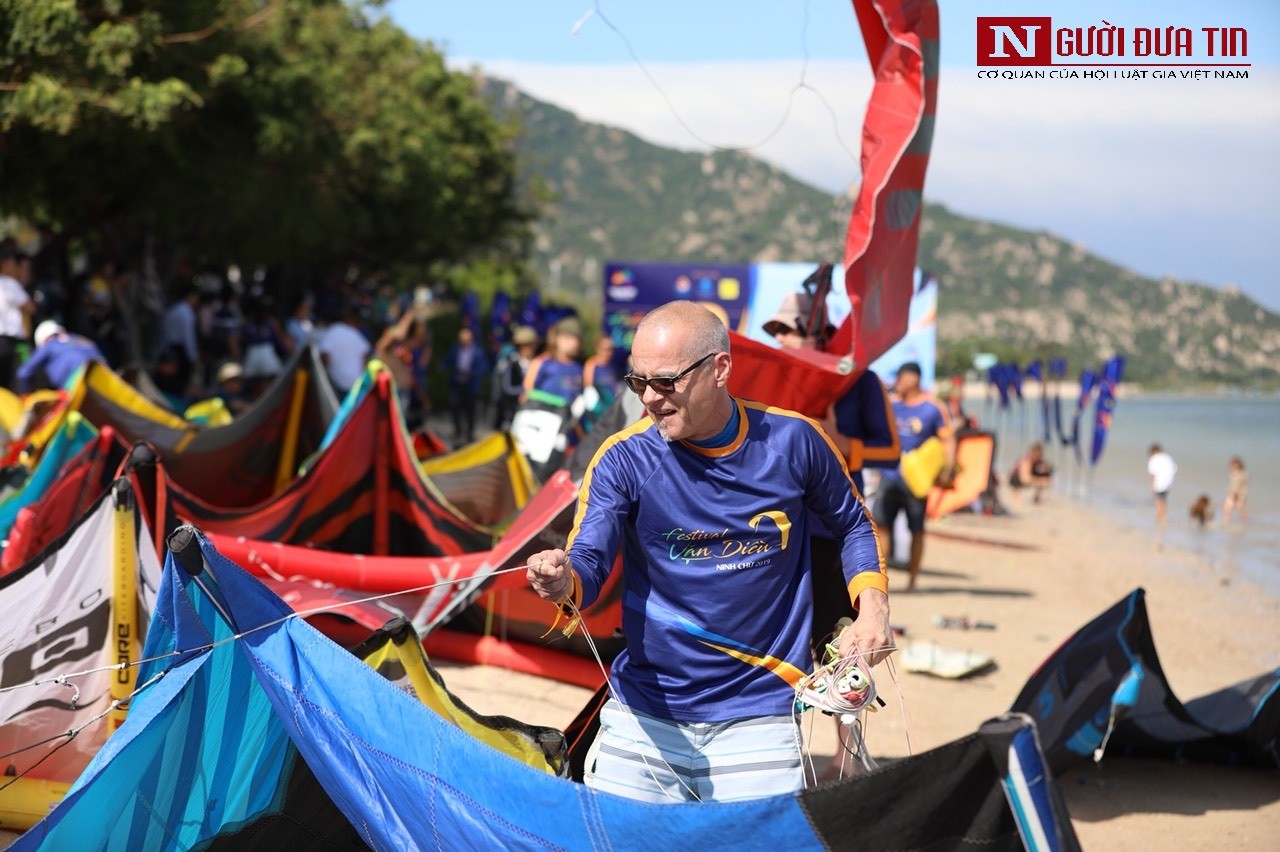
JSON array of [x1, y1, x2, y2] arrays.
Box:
[[568, 400, 888, 722]]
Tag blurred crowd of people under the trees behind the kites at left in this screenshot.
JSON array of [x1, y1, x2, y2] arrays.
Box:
[[0, 241, 634, 445]]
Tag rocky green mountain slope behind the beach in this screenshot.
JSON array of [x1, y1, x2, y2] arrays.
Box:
[[485, 81, 1280, 388]]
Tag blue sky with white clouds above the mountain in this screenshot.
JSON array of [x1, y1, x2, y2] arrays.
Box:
[[384, 0, 1280, 311]]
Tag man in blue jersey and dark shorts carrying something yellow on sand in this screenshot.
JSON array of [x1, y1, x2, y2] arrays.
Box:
[[876, 361, 956, 591]]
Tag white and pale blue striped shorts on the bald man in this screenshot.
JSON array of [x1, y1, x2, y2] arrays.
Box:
[[585, 698, 804, 802]]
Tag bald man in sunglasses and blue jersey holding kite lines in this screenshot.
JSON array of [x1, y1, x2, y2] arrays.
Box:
[[527, 302, 891, 802]]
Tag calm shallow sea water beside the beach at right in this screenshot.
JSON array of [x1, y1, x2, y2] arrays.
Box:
[[984, 395, 1280, 596]]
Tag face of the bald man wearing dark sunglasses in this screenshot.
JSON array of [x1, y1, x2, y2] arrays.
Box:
[[631, 329, 730, 441]]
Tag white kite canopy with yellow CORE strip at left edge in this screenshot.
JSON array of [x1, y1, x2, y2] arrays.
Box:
[[0, 482, 160, 826]]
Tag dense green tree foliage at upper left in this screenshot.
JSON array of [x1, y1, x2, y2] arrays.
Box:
[[0, 0, 527, 284]]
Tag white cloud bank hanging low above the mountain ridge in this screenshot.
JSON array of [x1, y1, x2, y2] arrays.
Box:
[[473, 60, 1280, 307]]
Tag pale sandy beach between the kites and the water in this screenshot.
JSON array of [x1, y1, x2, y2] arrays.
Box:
[[0, 494, 1280, 849]]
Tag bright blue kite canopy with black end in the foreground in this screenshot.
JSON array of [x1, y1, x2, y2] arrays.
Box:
[[13, 528, 1078, 851]]
